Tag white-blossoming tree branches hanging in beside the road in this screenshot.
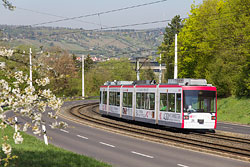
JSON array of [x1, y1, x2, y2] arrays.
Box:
[[0, 48, 67, 166]]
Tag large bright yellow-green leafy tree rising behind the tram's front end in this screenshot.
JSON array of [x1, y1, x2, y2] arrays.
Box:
[[178, 0, 250, 97]]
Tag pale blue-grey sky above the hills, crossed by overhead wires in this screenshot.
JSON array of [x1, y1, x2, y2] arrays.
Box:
[[0, 0, 202, 30]]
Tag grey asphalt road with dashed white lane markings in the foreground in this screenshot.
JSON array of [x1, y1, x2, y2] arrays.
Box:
[[4, 101, 250, 167]]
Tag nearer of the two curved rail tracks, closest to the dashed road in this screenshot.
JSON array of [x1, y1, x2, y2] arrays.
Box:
[[70, 103, 250, 161]]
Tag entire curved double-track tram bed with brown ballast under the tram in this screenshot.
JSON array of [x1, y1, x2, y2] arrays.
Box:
[[66, 103, 250, 162]]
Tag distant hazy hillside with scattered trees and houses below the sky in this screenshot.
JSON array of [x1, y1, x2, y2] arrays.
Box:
[[0, 25, 164, 57]]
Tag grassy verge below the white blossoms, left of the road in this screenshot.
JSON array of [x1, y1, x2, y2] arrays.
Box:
[[0, 124, 109, 167]]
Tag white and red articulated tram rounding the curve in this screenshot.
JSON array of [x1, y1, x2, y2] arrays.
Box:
[[99, 79, 217, 129]]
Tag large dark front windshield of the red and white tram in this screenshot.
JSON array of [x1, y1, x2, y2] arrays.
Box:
[[183, 90, 216, 113]]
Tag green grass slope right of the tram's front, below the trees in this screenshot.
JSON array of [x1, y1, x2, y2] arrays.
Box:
[[217, 97, 250, 125]]
